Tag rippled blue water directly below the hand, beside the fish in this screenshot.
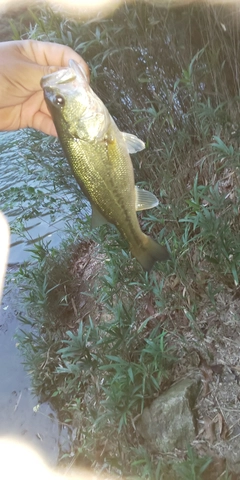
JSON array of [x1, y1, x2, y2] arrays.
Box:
[[0, 130, 78, 265]]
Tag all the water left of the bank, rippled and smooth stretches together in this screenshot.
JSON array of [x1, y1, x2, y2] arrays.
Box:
[[0, 131, 79, 464]]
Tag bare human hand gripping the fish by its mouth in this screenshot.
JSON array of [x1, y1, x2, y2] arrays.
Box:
[[0, 40, 89, 136]]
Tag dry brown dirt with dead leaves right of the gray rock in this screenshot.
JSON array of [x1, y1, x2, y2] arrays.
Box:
[[195, 291, 240, 478]]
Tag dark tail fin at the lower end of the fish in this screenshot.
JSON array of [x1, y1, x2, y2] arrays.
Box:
[[132, 235, 170, 272]]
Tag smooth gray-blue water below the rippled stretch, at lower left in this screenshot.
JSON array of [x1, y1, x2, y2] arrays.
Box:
[[0, 287, 68, 465]]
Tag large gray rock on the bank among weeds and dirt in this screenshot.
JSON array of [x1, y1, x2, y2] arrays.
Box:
[[137, 378, 201, 453]]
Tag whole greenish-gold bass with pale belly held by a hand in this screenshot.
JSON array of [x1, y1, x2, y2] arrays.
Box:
[[41, 60, 169, 272]]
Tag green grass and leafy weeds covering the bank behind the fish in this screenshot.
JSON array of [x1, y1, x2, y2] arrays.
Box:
[[2, 0, 240, 480]]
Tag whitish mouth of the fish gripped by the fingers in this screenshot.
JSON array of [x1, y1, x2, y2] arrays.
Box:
[[40, 59, 88, 89]]
